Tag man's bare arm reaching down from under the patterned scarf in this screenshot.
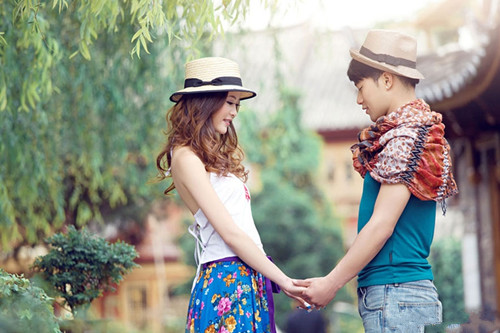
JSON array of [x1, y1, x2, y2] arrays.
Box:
[[296, 184, 411, 307]]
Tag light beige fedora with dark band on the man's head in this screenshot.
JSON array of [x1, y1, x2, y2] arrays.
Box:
[[350, 29, 424, 79]]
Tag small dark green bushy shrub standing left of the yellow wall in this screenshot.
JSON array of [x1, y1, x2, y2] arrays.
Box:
[[33, 226, 138, 315]]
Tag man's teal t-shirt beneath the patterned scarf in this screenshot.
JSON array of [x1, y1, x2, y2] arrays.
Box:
[[358, 173, 436, 287]]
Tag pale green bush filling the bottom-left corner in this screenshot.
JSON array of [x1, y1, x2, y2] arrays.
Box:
[[0, 269, 60, 333]]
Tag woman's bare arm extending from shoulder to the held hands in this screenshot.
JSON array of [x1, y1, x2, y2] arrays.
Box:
[[172, 148, 304, 294]]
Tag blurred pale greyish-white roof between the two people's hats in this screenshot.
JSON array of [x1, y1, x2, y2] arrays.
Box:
[[214, 24, 370, 130]]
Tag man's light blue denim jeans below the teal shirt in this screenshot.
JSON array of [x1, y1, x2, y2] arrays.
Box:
[[358, 280, 442, 333]]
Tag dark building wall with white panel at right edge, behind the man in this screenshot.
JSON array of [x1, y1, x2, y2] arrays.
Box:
[[450, 132, 500, 332]]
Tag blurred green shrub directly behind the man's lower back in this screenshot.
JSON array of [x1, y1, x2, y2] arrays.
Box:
[[425, 237, 469, 332]]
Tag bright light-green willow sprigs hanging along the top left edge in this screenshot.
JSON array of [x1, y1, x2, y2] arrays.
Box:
[[0, 0, 254, 111]]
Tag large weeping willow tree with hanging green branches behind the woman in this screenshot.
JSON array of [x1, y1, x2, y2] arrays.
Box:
[[0, 0, 268, 250]]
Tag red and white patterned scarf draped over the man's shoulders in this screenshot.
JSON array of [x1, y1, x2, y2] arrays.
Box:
[[351, 100, 458, 213]]
